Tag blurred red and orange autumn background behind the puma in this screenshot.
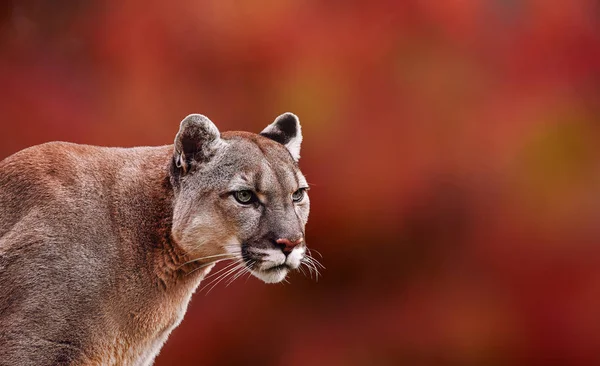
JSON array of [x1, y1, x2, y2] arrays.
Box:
[[0, 0, 600, 365]]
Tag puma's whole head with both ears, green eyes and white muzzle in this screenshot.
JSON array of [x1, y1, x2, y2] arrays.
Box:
[[173, 113, 310, 283]]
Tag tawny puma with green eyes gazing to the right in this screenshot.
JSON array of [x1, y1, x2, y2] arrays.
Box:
[[0, 113, 318, 366]]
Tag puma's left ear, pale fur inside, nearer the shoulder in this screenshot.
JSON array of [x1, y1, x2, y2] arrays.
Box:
[[174, 114, 221, 174]]
